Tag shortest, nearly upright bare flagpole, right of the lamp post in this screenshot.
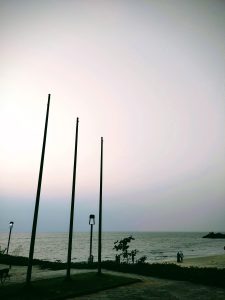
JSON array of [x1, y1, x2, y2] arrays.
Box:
[[98, 137, 103, 275]]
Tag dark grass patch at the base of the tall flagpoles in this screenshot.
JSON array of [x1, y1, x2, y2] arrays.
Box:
[[0, 272, 140, 300]]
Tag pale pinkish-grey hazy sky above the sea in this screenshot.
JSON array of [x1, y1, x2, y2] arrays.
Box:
[[0, 0, 225, 232]]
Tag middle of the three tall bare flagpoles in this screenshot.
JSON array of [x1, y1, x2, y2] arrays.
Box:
[[66, 118, 79, 280]]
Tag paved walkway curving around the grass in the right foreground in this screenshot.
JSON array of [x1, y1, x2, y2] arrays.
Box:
[[67, 271, 225, 300]]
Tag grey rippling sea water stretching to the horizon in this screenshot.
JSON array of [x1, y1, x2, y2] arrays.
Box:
[[0, 232, 225, 262]]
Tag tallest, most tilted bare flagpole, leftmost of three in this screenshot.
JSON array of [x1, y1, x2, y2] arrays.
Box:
[[26, 94, 51, 284]]
